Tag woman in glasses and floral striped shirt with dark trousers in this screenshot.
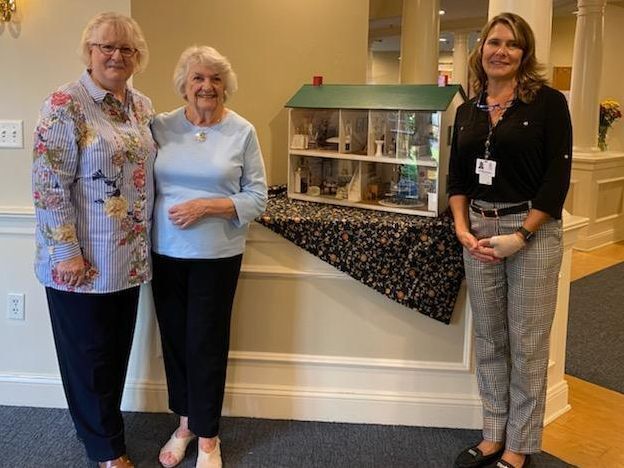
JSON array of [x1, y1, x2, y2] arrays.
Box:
[[32, 13, 156, 468]]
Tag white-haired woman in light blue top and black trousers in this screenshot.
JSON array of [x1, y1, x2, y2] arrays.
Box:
[[152, 46, 267, 468]]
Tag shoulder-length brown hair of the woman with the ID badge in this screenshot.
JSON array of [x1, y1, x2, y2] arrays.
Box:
[[468, 13, 547, 103]]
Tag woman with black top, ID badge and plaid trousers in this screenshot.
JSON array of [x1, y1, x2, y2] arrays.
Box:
[[448, 13, 572, 468]]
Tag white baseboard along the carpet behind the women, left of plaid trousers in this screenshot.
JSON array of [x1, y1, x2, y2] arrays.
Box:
[[0, 374, 481, 429]]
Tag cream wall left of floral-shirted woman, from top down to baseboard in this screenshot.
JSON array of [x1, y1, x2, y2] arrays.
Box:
[[0, 0, 130, 380]]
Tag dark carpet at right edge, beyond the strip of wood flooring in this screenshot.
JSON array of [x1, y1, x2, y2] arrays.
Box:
[[566, 263, 624, 393]]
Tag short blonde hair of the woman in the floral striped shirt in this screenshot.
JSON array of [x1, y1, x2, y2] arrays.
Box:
[[78, 12, 149, 72]]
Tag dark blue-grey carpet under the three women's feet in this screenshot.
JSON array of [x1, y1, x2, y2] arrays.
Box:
[[0, 406, 571, 468]]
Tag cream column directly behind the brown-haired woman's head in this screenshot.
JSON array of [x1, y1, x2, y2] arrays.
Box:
[[488, 0, 552, 66]]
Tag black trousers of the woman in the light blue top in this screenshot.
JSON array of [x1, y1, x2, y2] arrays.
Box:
[[152, 253, 242, 437]]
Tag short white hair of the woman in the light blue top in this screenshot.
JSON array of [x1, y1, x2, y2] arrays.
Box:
[[173, 45, 238, 100]]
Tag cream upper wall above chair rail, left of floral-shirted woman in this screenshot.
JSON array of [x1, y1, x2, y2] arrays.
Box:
[[0, 0, 130, 207]]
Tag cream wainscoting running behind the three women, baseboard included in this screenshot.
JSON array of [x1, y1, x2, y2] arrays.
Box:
[[0, 207, 582, 428]]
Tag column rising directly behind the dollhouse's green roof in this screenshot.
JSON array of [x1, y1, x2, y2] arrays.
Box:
[[399, 0, 440, 84]]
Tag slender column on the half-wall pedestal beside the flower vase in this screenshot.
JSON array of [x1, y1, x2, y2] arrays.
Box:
[[570, 0, 606, 152]]
